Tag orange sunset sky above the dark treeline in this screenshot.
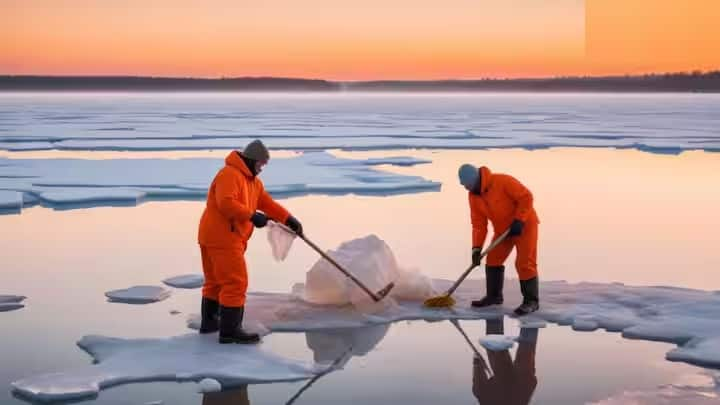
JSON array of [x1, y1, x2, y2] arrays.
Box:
[[0, 0, 720, 80]]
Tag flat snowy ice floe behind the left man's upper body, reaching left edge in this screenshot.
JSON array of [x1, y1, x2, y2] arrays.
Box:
[[0, 152, 440, 213]]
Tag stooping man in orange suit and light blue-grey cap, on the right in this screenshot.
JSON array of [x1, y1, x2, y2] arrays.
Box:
[[458, 164, 540, 315]]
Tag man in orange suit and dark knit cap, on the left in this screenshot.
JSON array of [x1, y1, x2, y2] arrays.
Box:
[[198, 140, 302, 343]]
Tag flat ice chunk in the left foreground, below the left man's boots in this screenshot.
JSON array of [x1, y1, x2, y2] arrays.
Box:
[[12, 333, 317, 401]]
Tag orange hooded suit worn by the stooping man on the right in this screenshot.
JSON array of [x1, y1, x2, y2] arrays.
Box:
[[468, 166, 540, 280]]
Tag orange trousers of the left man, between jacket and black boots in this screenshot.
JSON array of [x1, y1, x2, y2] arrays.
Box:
[[207, 248, 248, 307]]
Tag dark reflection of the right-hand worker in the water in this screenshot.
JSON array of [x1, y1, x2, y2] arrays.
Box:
[[473, 319, 538, 405]]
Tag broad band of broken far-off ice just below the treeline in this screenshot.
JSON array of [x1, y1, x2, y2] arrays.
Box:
[[0, 94, 720, 153]]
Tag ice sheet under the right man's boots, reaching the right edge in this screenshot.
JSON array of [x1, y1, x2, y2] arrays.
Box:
[[188, 279, 720, 367]]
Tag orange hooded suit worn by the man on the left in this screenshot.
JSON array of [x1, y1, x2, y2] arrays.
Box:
[[198, 151, 290, 307]]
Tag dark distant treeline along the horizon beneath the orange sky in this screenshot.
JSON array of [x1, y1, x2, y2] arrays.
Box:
[[0, 71, 720, 92]]
